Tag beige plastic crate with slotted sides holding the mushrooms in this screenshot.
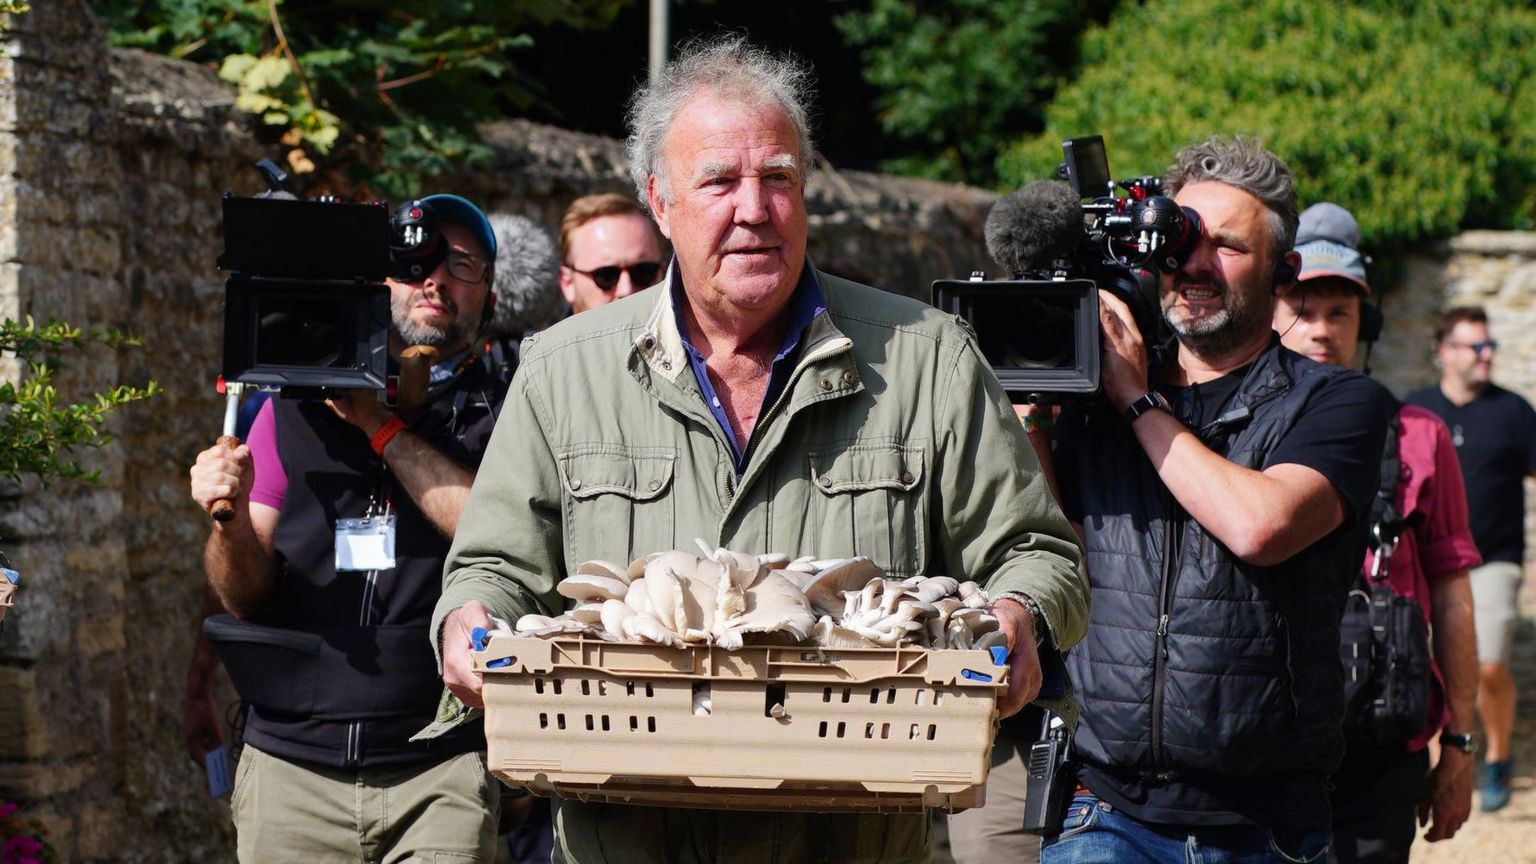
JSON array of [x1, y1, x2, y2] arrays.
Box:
[[475, 635, 1006, 813]]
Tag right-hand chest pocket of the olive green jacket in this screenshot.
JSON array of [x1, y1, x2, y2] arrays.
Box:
[[809, 444, 928, 578]]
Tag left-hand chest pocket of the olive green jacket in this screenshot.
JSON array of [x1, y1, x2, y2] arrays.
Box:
[[559, 444, 677, 566]]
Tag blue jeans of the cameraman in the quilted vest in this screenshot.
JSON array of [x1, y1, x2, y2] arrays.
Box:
[[1040, 792, 1329, 864]]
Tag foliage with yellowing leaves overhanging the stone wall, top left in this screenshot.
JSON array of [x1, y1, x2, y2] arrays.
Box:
[[94, 0, 624, 197]]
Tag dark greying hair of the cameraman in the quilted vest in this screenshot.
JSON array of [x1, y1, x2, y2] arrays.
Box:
[[1164, 135, 1301, 261]]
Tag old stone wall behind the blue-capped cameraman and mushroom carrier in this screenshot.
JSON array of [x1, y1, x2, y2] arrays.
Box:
[[0, 0, 991, 862]]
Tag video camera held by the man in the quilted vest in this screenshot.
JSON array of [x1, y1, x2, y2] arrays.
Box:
[[932, 135, 1201, 403]]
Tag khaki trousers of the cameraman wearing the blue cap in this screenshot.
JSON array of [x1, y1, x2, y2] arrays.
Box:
[[230, 744, 501, 864]]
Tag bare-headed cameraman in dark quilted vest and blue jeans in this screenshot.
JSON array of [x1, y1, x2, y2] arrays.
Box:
[[1041, 138, 1387, 864]]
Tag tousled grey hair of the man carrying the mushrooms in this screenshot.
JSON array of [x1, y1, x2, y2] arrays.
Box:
[[624, 34, 813, 210]]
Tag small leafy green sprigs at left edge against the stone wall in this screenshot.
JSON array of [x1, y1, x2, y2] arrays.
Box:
[[0, 318, 160, 484]]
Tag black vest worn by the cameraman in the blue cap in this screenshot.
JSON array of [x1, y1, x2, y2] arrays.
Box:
[[246, 363, 505, 767]]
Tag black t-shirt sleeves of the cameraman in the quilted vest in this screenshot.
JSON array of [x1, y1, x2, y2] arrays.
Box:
[[1158, 358, 1384, 515]]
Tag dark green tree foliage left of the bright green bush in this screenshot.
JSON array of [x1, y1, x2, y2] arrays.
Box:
[[836, 0, 1114, 186]]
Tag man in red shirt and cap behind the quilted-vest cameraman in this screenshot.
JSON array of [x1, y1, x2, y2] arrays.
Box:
[[1275, 203, 1482, 861]]
